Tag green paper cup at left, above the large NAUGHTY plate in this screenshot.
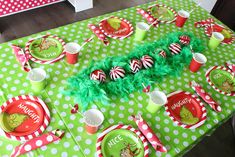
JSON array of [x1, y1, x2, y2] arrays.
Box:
[[28, 68, 46, 93]]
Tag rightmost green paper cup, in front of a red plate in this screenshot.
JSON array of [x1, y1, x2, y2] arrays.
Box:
[[208, 32, 224, 49]]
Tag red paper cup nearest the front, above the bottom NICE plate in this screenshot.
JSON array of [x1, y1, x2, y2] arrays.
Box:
[[84, 109, 104, 134]]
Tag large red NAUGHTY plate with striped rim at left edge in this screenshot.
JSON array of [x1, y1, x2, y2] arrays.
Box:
[[0, 95, 50, 141]]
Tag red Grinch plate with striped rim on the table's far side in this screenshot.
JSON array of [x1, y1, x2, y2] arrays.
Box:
[[99, 16, 133, 39]]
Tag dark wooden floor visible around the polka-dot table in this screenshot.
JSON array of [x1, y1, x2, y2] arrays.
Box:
[[0, 0, 235, 157]]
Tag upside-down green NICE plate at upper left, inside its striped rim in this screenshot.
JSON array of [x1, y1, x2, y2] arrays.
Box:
[[29, 37, 63, 60]]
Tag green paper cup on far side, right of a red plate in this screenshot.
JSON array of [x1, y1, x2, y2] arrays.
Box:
[[135, 22, 149, 41]]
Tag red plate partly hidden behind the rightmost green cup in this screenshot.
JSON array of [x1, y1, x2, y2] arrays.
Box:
[[205, 24, 235, 44]]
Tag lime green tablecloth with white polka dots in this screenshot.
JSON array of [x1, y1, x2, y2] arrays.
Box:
[[0, 0, 235, 157]]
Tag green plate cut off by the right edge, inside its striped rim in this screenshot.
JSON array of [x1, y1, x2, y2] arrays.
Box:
[[209, 69, 235, 93]]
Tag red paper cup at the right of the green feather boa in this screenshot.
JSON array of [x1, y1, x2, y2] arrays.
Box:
[[189, 53, 207, 72]]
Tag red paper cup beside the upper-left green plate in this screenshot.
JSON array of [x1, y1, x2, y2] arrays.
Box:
[[65, 43, 81, 64]]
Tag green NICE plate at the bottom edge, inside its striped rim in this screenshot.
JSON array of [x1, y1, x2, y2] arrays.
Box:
[[101, 129, 144, 157]]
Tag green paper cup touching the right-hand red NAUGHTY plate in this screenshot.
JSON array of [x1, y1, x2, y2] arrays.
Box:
[[146, 91, 167, 113]]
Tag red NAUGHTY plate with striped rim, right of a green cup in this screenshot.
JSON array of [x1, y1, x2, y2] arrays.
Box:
[[165, 91, 206, 129]]
